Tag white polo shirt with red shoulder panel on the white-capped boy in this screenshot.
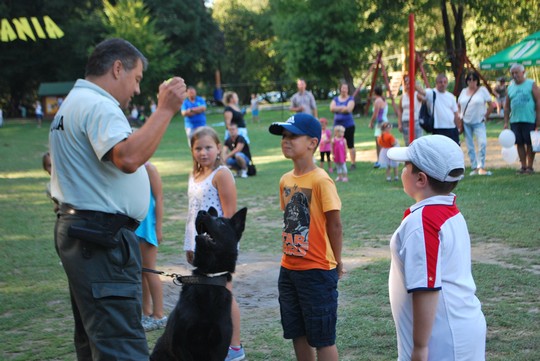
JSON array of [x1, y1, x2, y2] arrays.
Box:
[[388, 194, 486, 361]]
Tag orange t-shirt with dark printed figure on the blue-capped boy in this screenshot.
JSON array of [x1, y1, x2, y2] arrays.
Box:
[[279, 168, 341, 271]]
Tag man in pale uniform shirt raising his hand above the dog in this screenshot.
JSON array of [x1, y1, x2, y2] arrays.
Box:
[[49, 39, 186, 361]]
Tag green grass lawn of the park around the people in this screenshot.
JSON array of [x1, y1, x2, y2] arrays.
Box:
[[0, 104, 540, 361]]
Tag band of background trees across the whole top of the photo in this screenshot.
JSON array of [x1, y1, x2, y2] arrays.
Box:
[[0, 0, 540, 116]]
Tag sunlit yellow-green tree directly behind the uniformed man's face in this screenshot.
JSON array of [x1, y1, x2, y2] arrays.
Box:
[[102, 0, 178, 103]]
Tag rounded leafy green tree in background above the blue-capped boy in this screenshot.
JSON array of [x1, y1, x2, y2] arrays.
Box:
[[270, 0, 369, 85]]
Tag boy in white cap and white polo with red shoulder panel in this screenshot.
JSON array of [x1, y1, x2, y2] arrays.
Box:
[[388, 135, 486, 361]]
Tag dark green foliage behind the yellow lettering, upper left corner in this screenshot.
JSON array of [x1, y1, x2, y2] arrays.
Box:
[[0, 0, 102, 117]]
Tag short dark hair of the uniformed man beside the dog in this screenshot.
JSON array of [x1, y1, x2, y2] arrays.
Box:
[[85, 38, 148, 77]]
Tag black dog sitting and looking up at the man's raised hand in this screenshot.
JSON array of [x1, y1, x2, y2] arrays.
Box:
[[150, 208, 247, 361]]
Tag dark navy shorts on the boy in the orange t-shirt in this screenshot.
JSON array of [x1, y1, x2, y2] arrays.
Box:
[[278, 267, 338, 348]]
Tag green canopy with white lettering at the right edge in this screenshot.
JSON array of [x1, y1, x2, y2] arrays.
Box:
[[480, 31, 540, 70]]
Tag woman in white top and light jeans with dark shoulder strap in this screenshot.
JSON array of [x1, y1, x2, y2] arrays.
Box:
[[458, 72, 494, 175]]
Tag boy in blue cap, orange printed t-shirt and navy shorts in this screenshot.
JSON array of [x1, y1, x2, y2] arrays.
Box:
[[269, 113, 344, 361]]
